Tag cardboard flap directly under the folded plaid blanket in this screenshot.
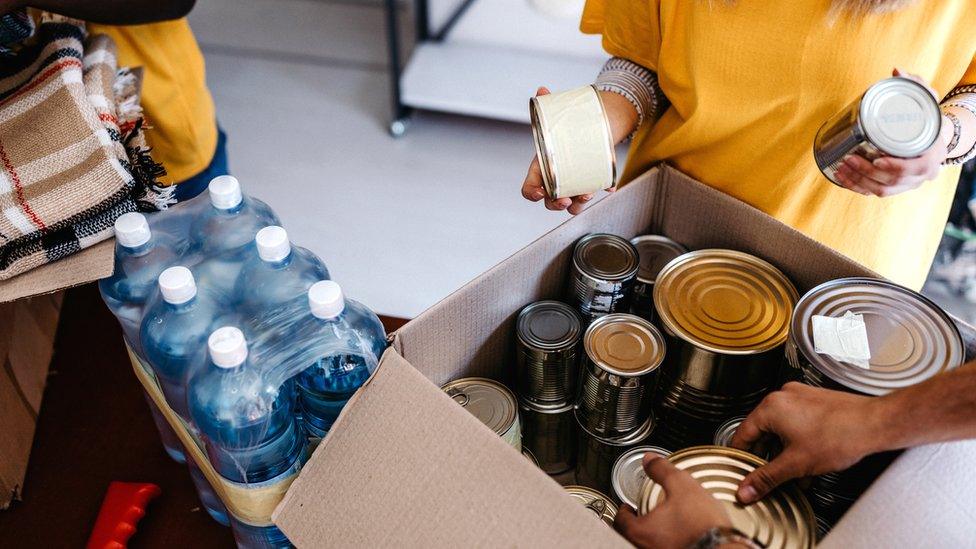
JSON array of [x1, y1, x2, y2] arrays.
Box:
[[0, 238, 115, 303]]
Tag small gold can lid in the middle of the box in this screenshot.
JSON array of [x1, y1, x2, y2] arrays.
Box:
[[583, 313, 665, 377]]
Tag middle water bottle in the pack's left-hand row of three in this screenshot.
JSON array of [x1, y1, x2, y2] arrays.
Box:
[[141, 266, 229, 526]]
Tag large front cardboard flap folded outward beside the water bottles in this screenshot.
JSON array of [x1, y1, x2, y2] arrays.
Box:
[[272, 351, 628, 547]]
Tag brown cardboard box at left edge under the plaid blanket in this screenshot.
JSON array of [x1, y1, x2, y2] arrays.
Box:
[[0, 242, 114, 509]]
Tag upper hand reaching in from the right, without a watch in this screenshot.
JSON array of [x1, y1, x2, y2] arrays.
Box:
[[731, 382, 885, 504]]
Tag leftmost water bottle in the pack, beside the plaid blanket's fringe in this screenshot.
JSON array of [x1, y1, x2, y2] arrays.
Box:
[[98, 212, 186, 463]]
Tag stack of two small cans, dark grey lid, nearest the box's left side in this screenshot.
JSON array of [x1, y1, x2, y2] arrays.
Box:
[[515, 301, 583, 474]]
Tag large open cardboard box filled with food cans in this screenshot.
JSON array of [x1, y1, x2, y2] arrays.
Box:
[[273, 167, 976, 547]]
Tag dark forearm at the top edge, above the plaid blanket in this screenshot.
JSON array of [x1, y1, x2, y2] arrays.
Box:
[[8, 0, 195, 25]]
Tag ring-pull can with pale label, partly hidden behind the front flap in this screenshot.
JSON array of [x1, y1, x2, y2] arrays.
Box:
[[441, 377, 522, 452]]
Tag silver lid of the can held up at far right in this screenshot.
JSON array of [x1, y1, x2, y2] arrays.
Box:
[[860, 76, 942, 158]]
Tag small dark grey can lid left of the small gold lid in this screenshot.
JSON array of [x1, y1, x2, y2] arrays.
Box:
[[515, 301, 583, 351]]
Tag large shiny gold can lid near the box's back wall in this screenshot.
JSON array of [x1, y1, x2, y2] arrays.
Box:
[[654, 250, 799, 355]]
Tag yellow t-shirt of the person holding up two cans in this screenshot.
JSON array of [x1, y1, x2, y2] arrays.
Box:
[[581, 0, 976, 289]]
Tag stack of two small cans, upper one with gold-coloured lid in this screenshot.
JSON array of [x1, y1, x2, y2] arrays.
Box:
[[576, 313, 665, 492]]
